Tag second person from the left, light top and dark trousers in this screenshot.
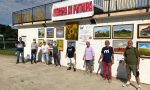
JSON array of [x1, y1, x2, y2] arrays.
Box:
[[31, 39, 38, 64]]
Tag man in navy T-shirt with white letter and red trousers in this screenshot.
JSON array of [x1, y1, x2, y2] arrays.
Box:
[[98, 40, 114, 83]]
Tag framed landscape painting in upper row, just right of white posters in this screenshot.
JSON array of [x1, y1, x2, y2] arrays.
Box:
[[94, 26, 111, 39]]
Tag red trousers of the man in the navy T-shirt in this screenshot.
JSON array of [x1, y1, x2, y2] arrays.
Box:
[[102, 62, 112, 80]]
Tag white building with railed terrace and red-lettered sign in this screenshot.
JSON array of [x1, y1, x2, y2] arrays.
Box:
[[13, 0, 150, 84]]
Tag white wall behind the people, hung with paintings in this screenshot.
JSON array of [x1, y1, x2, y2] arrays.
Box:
[[18, 15, 150, 84]]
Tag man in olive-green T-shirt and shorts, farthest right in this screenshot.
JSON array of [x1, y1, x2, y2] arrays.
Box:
[[123, 40, 141, 90]]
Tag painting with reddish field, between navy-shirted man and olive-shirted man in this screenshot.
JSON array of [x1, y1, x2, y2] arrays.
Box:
[[113, 40, 128, 54]]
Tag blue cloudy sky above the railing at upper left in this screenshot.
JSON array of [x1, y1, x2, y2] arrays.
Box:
[[0, 0, 59, 25]]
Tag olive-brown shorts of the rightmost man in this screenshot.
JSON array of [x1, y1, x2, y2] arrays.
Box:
[[126, 65, 139, 77]]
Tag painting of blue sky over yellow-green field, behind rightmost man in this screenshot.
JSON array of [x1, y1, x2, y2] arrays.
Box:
[[137, 41, 150, 58]]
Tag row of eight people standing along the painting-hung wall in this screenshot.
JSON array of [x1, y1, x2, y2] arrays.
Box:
[[16, 37, 141, 90]]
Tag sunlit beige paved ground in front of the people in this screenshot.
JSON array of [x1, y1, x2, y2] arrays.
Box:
[[0, 55, 150, 90]]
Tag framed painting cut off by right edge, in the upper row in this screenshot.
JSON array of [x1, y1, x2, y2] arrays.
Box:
[[137, 23, 150, 38]]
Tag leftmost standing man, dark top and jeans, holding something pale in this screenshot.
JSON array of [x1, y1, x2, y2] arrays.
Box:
[[15, 37, 25, 64]]
